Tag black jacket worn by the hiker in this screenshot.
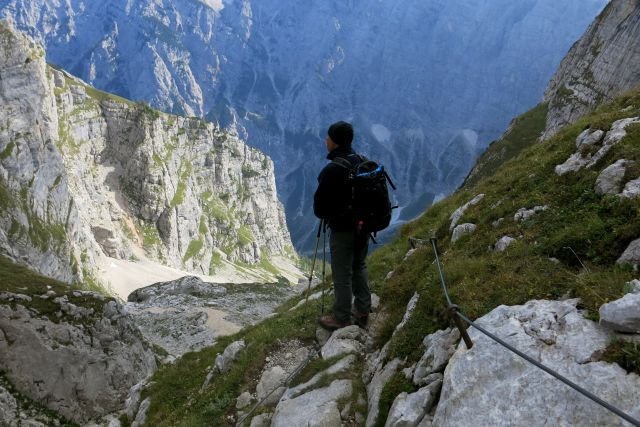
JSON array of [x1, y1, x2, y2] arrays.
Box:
[[313, 145, 361, 231]]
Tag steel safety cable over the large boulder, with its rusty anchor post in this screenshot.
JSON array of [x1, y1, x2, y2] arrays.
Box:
[[430, 237, 640, 427]]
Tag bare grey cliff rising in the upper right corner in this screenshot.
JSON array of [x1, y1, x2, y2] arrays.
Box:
[[543, 0, 640, 139]]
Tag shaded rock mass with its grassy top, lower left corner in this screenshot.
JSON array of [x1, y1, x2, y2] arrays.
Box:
[[0, 257, 156, 426]]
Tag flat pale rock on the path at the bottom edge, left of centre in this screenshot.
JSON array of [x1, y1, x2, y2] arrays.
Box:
[[271, 380, 353, 427]]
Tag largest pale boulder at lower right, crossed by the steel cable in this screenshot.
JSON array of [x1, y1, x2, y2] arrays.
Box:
[[433, 300, 640, 426]]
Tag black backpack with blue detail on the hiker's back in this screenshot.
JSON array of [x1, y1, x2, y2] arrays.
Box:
[[333, 155, 397, 234]]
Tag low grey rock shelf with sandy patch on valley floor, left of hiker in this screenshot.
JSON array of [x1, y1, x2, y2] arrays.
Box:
[[125, 276, 302, 358]]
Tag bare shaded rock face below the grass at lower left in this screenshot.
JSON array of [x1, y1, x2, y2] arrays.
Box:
[[0, 297, 156, 423]]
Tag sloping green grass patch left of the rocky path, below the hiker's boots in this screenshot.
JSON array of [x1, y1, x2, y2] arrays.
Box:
[[143, 305, 318, 426]]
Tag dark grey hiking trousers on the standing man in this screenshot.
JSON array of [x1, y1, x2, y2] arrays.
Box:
[[329, 230, 371, 323]]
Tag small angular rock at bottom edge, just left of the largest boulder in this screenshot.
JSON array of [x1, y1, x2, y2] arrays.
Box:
[[385, 381, 442, 427]]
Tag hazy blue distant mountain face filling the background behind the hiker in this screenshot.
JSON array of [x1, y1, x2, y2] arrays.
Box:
[[0, 0, 606, 249]]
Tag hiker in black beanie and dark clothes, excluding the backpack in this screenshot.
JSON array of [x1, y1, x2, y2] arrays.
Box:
[[313, 121, 371, 330]]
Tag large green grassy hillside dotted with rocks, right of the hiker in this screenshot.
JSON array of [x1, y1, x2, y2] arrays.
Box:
[[369, 88, 640, 361]]
